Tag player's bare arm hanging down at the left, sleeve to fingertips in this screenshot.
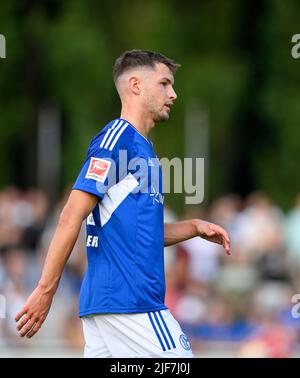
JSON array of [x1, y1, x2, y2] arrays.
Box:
[[15, 190, 97, 337]]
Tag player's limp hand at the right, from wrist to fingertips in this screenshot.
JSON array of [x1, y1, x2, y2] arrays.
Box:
[[196, 219, 231, 255]]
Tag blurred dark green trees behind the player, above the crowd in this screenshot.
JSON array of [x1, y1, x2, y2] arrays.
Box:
[[0, 0, 300, 211]]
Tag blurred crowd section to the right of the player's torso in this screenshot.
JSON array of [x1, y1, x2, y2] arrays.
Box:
[[166, 192, 300, 357]]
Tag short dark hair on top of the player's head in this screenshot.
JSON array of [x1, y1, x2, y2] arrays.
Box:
[[113, 50, 180, 83]]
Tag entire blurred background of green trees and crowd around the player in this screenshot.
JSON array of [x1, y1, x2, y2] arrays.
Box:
[[0, 0, 300, 357]]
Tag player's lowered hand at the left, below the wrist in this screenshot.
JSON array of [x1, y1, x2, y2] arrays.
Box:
[[15, 286, 53, 338]]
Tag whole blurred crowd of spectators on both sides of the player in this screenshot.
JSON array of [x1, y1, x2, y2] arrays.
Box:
[[0, 187, 300, 357]]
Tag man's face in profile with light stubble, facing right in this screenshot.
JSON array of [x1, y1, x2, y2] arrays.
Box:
[[141, 63, 177, 122]]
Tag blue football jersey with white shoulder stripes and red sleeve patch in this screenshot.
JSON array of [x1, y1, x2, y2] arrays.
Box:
[[73, 118, 167, 317]]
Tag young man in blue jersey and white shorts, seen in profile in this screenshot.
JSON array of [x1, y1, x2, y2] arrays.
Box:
[[16, 50, 230, 357]]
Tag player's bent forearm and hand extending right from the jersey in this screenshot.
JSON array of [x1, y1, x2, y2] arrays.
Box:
[[164, 219, 230, 255]]
